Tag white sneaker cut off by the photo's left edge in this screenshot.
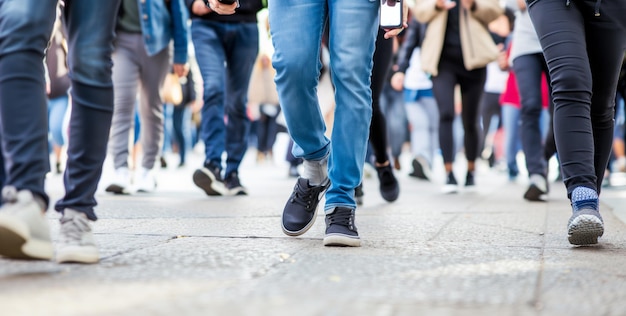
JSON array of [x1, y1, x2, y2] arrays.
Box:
[[0, 186, 54, 260]]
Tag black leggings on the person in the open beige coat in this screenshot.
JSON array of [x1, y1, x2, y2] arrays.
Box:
[[432, 47, 487, 163]]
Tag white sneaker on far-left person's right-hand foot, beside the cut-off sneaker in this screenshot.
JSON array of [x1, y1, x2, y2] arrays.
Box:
[[56, 208, 100, 263]]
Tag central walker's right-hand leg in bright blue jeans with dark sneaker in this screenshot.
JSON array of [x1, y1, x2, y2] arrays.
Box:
[[324, 0, 379, 246]]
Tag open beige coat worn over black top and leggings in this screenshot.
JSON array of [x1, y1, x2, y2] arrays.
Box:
[[413, 0, 503, 76]]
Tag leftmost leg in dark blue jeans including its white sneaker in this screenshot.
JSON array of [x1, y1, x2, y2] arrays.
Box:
[[0, 0, 56, 260]]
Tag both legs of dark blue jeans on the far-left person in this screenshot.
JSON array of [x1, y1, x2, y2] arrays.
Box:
[[0, 0, 120, 220]]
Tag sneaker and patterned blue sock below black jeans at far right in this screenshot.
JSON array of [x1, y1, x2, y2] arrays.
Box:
[[567, 187, 604, 245]]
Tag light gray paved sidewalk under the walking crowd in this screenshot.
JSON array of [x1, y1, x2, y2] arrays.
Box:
[[0, 146, 626, 316]]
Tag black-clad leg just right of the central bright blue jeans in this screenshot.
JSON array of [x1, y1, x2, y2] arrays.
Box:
[[370, 30, 393, 164]]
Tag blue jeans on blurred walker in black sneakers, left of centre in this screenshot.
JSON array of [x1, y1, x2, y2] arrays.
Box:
[[191, 19, 259, 177]]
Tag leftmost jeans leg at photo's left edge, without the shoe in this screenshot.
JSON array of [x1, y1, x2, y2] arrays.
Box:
[[0, 0, 56, 204]]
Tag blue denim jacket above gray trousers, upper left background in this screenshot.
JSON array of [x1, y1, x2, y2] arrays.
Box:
[[137, 0, 189, 64]]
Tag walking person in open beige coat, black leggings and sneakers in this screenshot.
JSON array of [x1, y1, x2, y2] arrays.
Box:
[[413, 0, 503, 193]]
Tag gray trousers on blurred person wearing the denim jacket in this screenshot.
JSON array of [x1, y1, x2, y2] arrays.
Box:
[[109, 32, 170, 169]]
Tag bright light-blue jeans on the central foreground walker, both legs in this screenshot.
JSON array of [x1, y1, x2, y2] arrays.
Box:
[[269, 0, 379, 213]]
